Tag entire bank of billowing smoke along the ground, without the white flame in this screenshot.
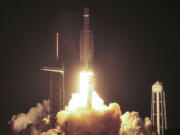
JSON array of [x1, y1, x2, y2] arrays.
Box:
[[9, 100, 156, 135]]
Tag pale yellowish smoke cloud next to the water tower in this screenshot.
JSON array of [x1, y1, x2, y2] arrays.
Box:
[[120, 112, 156, 135]]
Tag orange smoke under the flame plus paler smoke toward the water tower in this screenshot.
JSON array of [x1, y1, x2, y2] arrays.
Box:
[[41, 109, 157, 135]]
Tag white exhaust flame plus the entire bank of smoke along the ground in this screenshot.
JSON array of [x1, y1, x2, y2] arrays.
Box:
[[10, 72, 156, 135]]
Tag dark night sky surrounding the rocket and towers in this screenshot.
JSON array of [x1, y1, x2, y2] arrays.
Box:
[[1, 0, 180, 131]]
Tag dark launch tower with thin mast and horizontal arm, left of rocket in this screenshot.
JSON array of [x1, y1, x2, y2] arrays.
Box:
[[41, 33, 64, 128]]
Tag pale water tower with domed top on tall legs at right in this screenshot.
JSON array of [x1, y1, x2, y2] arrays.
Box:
[[151, 81, 167, 135]]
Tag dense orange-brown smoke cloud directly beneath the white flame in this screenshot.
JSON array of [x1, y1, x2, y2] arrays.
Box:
[[57, 103, 121, 135]]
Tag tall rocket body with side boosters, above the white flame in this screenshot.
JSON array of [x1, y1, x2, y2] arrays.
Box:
[[80, 8, 93, 71]]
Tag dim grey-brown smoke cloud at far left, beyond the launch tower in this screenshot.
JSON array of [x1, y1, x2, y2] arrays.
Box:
[[9, 100, 50, 135]]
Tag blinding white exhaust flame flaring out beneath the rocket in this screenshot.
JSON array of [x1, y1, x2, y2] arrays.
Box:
[[66, 71, 105, 111]]
